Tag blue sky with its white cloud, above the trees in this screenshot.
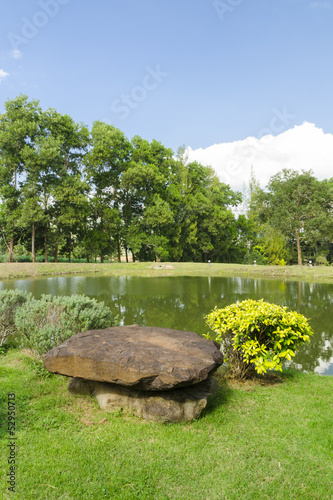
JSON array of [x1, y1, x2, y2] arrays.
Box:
[[0, 0, 333, 189]]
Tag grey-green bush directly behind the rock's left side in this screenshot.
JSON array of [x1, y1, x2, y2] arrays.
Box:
[[15, 295, 116, 355]]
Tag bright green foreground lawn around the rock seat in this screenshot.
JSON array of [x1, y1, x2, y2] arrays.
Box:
[[0, 350, 333, 500]]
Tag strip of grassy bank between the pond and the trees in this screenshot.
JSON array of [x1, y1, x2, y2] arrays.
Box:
[[0, 262, 333, 283]]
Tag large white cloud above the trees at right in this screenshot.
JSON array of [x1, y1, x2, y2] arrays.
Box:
[[188, 122, 333, 191]]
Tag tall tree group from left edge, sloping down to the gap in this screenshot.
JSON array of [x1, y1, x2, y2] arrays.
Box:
[[0, 96, 254, 262]]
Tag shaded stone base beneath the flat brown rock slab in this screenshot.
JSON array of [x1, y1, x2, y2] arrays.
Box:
[[68, 378, 217, 422]]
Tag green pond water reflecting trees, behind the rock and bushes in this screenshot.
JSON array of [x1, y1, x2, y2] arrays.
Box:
[[0, 275, 333, 375]]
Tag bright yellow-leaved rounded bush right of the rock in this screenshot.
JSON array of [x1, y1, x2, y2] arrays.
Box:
[[206, 300, 313, 379]]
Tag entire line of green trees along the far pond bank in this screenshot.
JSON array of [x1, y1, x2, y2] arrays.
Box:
[[0, 95, 333, 264]]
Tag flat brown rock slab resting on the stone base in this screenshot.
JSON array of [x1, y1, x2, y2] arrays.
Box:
[[44, 325, 223, 391]]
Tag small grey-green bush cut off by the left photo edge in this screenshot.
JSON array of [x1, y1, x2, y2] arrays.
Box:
[[0, 290, 32, 347]]
